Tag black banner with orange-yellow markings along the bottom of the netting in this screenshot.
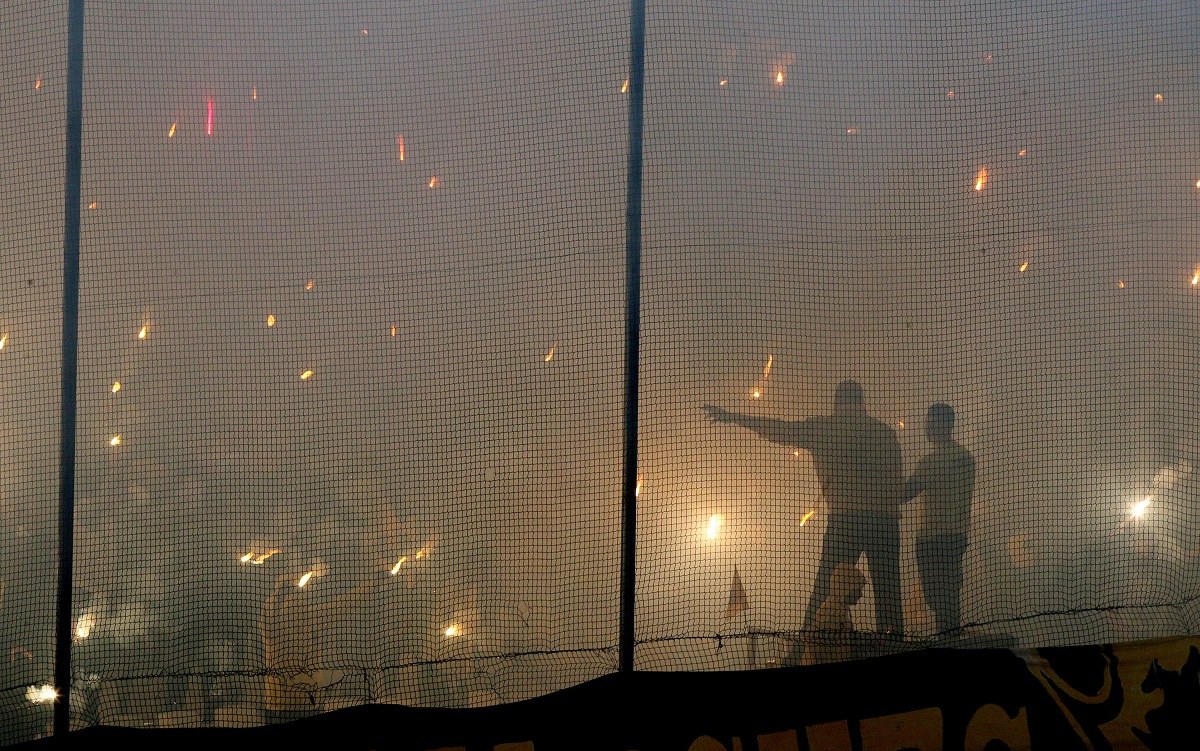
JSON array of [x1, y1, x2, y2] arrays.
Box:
[[18, 637, 1200, 751]]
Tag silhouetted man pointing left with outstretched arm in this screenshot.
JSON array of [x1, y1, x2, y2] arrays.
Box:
[[704, 379, 904, 636]]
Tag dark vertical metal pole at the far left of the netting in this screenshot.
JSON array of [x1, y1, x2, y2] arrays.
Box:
[[54, 0, 84, 735]]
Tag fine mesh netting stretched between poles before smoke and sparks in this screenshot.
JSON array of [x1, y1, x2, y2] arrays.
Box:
[[0, 1, 1200, 743]]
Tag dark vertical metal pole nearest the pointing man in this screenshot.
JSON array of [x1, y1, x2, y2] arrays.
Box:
[[620, 0, 646, 673]]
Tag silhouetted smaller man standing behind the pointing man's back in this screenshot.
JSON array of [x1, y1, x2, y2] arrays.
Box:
[[904, 402, 974, 633]]
